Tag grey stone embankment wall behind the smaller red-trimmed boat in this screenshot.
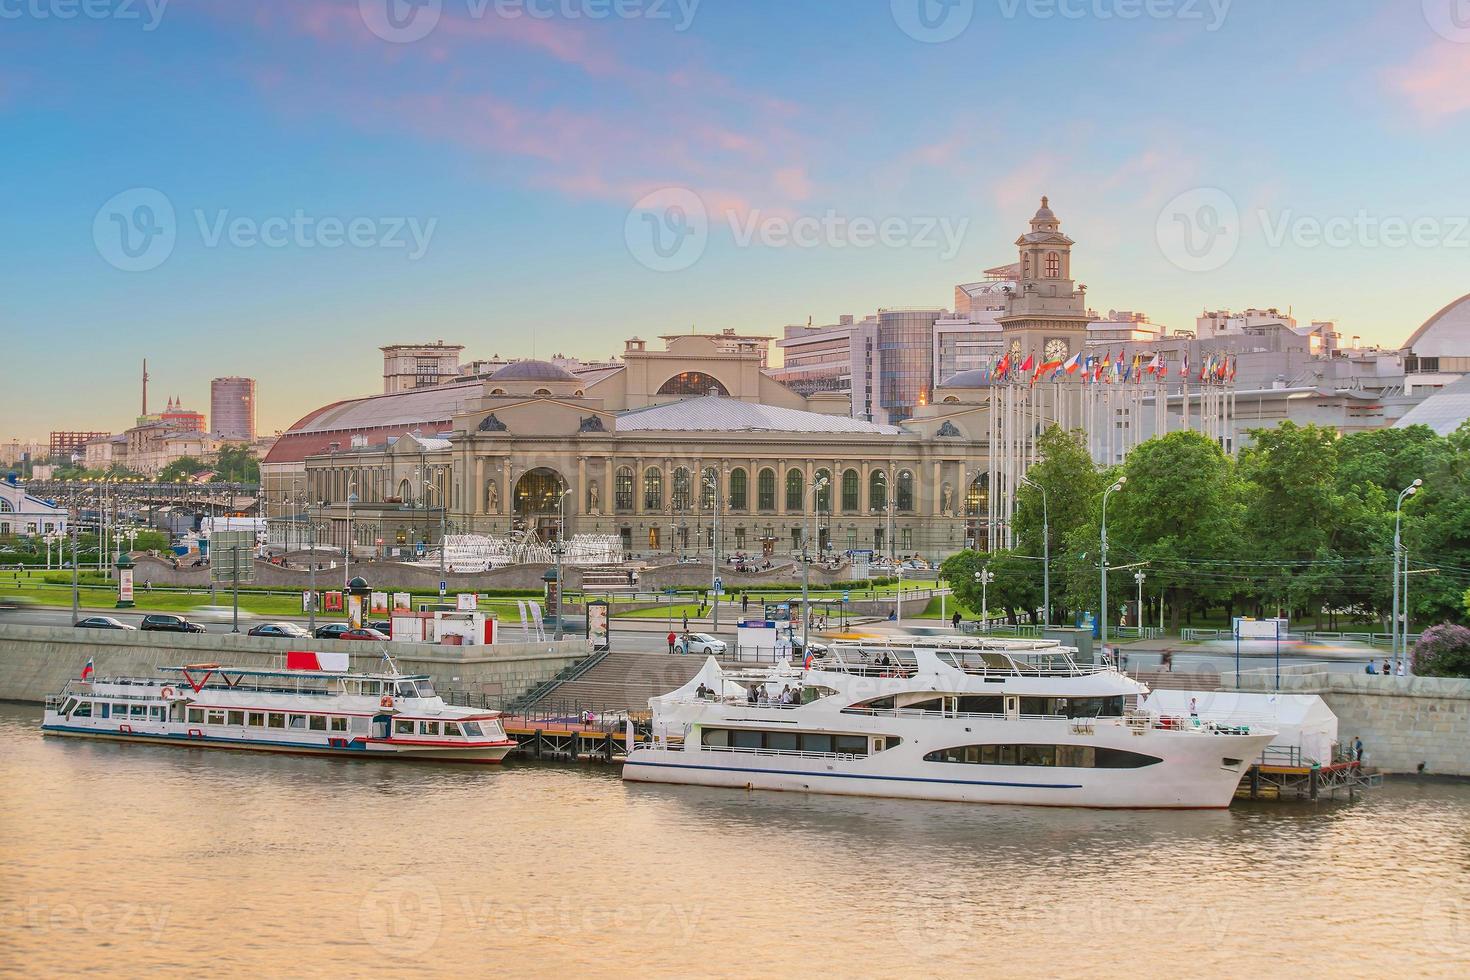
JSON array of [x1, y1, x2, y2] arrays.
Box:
[[0, 624, 587, 701]]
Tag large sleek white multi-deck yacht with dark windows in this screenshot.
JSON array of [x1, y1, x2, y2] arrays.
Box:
[[623, 641, 1274, 808]]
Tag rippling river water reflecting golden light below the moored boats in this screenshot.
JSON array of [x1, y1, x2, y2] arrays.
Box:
[[0, 704, 1470, 977]]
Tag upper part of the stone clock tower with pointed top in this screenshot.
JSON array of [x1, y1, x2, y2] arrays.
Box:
[[997, 197, 1092, 361]]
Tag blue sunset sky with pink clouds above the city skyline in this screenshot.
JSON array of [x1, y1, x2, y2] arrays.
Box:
[[0, 0, 1470, 438]]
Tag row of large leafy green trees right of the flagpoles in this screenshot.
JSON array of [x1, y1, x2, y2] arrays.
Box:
[[942, 422, 1470, 629]]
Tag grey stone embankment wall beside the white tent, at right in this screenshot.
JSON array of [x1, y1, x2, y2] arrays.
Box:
[[1223, 671, 1470, 776]]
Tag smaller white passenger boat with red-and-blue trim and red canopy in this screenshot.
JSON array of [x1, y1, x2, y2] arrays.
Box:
[[41, 654, 515, 763]]
